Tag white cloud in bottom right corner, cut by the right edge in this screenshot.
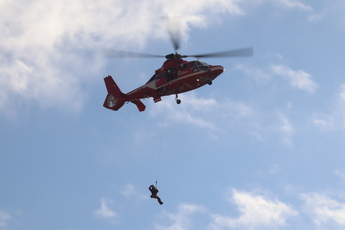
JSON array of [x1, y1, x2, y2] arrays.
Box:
[[302, 193, 345, 227]]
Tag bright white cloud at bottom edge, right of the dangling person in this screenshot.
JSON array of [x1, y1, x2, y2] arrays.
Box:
[[210, 189, 298, 230]]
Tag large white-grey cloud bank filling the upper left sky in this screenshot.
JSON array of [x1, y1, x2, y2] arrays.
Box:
[[0, 0, 242, 117]]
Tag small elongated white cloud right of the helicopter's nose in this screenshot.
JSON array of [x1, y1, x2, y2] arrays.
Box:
[[271, 65, 317, 93]]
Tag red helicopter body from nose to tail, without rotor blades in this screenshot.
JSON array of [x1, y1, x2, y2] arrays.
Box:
[[103, 57, 224, 111]]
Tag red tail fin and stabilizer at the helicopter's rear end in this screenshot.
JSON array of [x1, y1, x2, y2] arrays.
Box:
[[103, 75, 146, 112]]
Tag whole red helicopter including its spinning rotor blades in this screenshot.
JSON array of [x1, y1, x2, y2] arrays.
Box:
[[103, 29, 253, 112]]
